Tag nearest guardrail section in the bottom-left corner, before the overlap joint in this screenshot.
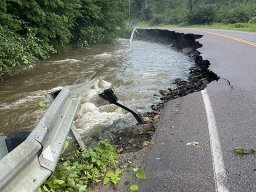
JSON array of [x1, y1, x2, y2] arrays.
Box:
[[0, 137, 51, 192]]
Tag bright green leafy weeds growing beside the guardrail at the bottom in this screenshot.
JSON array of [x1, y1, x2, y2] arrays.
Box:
[[38, 141, 122, 192]]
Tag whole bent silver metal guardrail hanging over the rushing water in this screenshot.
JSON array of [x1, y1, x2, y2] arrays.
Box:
[[0, 85, 83, 192]]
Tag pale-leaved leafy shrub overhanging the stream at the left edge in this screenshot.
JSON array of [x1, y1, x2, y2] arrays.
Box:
[[0, 26, 56, 76]]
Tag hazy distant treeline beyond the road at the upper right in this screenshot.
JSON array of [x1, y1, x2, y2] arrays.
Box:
[[130, 0, 256, 24]]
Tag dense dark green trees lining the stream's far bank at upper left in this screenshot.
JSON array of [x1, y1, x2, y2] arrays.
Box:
[[0, 0, 129, 76]]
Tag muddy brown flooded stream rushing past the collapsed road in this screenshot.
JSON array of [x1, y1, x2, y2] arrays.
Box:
[[0, 39, 194, 138]]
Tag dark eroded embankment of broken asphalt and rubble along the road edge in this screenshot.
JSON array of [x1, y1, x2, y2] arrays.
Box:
[[113, 29, 219, 152]]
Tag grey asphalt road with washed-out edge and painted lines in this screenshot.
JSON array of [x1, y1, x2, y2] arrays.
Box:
[[140, 29, 256, 192]]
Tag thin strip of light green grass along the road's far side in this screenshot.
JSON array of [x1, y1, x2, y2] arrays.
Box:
[[138, 23, 256, 32]]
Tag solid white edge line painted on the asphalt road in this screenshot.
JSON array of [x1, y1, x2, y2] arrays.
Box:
[[201, 89, 229, 192]]
